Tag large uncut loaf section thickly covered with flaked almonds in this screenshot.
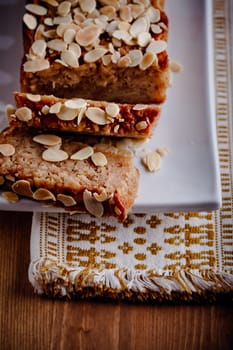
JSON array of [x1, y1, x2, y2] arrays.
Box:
[[21, 0, 169, 104]]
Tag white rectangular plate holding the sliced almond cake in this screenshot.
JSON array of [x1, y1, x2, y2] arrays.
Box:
[[0, 0, 221, 212]]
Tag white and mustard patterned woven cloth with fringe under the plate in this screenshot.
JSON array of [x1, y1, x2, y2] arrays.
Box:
[[29, 0, 233, 301]]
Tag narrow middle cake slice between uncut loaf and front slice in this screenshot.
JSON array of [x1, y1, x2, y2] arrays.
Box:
[[9, 92, 160, 138]]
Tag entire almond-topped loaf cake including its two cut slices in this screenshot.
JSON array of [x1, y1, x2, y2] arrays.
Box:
[[0, 0, 169, 220]]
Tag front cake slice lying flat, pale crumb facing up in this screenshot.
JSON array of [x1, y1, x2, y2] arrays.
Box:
[[0, 127, 139, 220]]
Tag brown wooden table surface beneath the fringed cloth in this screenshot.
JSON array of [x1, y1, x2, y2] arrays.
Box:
[[0, 212, 233, 350]]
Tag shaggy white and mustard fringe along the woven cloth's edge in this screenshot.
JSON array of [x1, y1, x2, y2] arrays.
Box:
[[28, 258, 233, 301]]
